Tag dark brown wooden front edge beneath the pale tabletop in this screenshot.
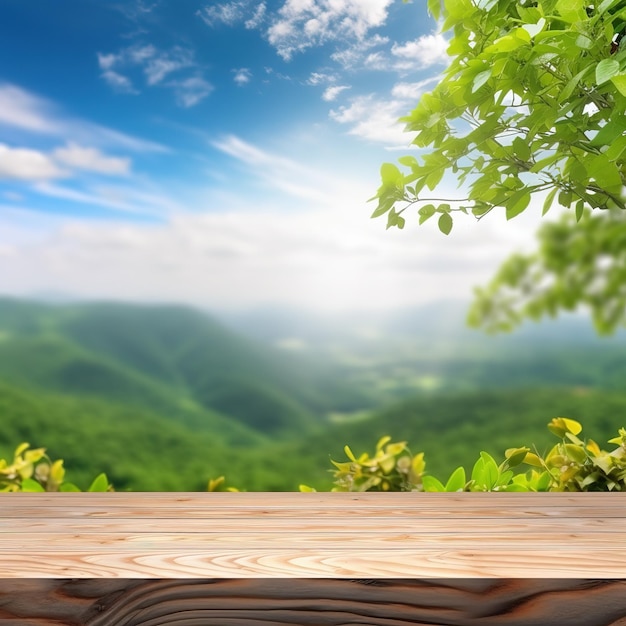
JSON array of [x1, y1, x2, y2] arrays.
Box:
[[0, 578, 626, 626]]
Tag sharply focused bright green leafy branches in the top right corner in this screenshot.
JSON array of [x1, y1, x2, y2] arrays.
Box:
[[374, 0, 626, 234]]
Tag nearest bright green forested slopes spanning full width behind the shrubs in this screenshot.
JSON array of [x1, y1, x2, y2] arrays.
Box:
[[0, 378, 626, 491]]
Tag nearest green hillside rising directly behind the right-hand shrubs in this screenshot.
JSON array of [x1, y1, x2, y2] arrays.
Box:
[[293, 389, 626, 484]]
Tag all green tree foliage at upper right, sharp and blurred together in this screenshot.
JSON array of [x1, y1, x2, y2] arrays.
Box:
[[373, 0, 626, 332]]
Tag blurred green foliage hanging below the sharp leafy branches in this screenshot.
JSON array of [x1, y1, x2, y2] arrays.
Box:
[[468, 206, 626, 334]]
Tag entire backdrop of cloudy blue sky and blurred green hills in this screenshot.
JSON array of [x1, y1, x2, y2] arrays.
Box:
[[0, 0, 626, 491]]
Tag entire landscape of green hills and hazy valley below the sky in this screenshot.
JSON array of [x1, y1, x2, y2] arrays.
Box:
[[0, 298, 626, 491]]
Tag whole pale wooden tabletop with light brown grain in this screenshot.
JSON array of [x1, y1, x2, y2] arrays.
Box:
[[0, 492, 626, 579]]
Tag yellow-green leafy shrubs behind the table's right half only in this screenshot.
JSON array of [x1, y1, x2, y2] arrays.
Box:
[[300, 417, 626, 492]]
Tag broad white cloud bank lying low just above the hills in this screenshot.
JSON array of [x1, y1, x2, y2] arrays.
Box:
[[0, 182, 540, 313]]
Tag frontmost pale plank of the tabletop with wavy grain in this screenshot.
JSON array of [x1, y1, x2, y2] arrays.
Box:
[[0, 545, 626, 579]]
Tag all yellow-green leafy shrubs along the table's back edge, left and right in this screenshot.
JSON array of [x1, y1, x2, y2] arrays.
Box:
[[0, 417, 626, 492]]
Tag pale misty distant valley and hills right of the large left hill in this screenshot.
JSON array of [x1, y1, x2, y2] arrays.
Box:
[[224, 301, 626, 403]]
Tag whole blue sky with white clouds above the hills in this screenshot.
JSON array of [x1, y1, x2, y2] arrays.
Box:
[[0, 0, 536, 311]]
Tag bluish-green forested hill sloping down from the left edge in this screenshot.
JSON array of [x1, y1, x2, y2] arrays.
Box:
[[0, 298, 365, 436]]
